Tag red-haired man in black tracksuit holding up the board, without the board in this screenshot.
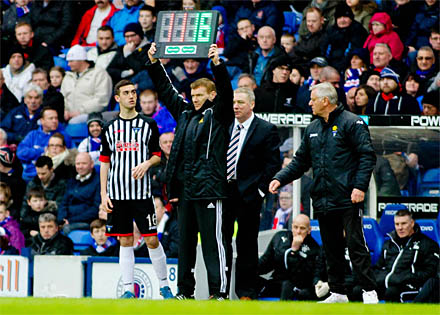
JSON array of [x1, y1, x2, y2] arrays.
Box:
[[147, 43, 234, 300]]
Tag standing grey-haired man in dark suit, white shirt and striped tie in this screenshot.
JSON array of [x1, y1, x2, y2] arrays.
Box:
[[223, 88, 281, 300]]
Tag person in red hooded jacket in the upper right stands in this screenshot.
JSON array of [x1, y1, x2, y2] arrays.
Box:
[[364, 12, 404, 63]]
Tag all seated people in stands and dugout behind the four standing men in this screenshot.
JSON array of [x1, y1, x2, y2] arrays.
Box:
[[0, 0, 440, 302]]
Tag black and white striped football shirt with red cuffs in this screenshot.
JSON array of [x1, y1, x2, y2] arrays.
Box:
[[99, 114, 160, 200]]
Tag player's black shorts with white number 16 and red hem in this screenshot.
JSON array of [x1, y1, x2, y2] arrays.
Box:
[[105, 198, 157, 236]]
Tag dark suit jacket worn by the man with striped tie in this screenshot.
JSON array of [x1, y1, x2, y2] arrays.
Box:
[[229, 116, 281, 202]]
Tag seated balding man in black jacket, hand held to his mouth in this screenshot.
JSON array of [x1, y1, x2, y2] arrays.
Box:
[[258, 214, 320, 300]]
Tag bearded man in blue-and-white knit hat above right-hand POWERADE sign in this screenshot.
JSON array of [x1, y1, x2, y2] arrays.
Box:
[[366, 67, 420, 115]]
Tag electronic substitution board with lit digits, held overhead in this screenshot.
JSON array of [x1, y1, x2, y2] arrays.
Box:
[[154, 11, 220, 58]]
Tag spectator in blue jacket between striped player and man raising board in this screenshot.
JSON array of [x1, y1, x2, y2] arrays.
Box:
[[139, 90, 177, 134]]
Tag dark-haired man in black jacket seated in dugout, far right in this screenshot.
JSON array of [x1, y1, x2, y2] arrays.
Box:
[[375, 210, 439, 302]]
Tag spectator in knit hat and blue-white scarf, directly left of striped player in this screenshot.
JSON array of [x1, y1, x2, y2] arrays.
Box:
[[78, 113, 104, 165]]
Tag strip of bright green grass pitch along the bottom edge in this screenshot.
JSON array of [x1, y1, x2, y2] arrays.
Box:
[[0, 297, 440, 315]]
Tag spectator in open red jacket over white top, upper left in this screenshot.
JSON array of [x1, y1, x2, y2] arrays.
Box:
[[70, 0, 118, 47]]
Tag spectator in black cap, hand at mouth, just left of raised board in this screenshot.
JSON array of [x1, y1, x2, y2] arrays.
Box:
[[107, 22, 154, 90]]
